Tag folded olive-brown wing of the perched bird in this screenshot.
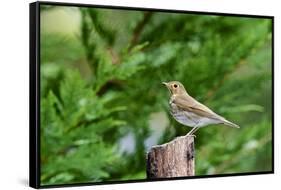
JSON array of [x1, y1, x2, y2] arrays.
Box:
[[173, 95, 223, 120]]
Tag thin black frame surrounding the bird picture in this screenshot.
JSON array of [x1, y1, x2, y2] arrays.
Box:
[[29, 1, 274, 188]]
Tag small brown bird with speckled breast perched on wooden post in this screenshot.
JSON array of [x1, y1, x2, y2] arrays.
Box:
[[162, 81, 240, 136]]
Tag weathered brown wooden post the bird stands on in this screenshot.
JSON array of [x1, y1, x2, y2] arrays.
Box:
[[146, 136, 195, 179]]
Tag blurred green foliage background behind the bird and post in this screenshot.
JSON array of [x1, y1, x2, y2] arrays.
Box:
[[40, 5, 272, 185]]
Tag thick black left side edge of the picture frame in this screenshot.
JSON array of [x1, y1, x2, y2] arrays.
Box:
[[29, 2, 40, 188]]
